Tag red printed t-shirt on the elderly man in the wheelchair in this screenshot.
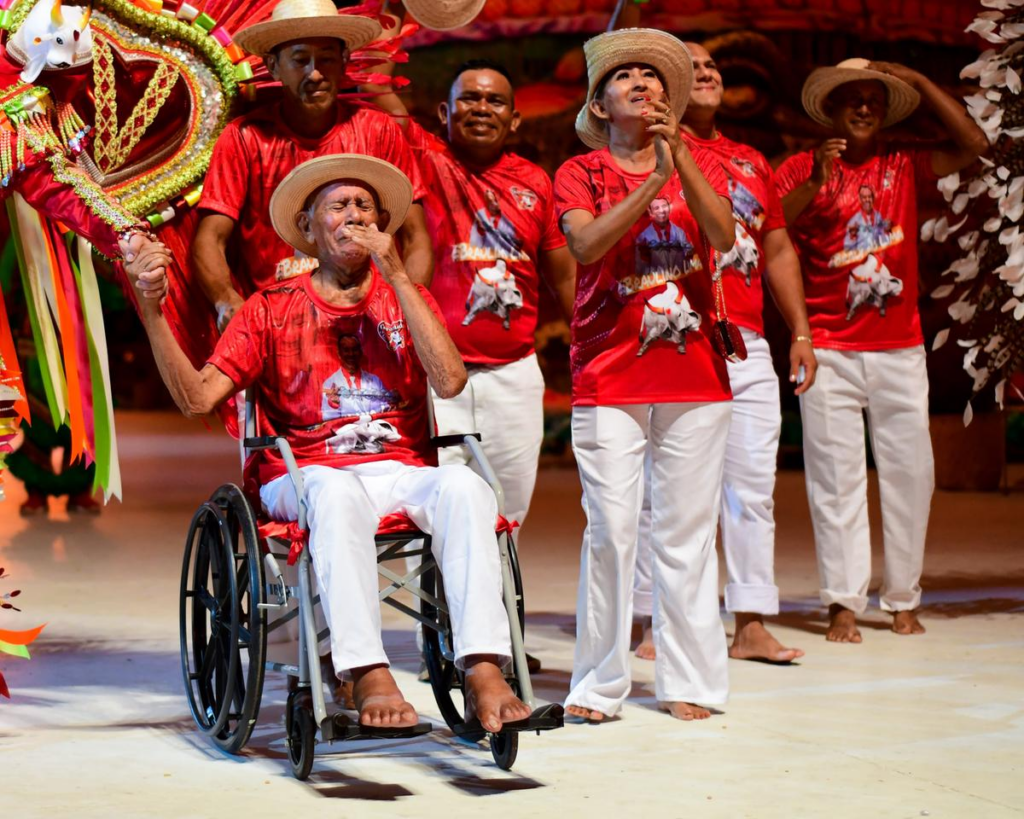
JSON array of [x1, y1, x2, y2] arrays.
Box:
[[210, 270, 443, 483]]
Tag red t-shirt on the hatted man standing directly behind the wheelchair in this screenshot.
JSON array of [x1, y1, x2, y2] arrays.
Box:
[[199, 102, 424, 296]]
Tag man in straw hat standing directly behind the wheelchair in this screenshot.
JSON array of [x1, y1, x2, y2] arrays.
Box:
[[193, 0, 433, 330]]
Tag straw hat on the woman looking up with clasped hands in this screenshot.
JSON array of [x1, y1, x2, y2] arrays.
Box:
[[577, 29, 693, 148]]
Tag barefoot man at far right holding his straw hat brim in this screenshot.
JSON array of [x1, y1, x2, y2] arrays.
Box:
[[776, 58, 988, 643]]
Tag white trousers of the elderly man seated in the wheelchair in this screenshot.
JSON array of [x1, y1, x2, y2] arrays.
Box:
[[260, 461, 512, 676]]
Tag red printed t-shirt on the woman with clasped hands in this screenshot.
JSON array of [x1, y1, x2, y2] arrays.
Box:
[[555, 148, 731, 406]]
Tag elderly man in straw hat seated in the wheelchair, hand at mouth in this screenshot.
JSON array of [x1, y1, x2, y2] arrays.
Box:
[[123, 155, 529, 731]]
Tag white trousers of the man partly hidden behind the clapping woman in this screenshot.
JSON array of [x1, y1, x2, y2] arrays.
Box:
[[633, 328, 782, 617]]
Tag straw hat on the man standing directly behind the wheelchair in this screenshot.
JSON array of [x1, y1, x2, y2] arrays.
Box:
[[234, 0, 381, 56]]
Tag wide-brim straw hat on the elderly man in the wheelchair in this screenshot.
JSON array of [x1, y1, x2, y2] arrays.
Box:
[[270, 154, 413, 256]]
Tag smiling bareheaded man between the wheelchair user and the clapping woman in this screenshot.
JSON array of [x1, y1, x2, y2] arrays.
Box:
[[368, 59, 575, 544]]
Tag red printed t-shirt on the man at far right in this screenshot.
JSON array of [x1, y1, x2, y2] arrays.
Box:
[[775, 147, 936, 350]]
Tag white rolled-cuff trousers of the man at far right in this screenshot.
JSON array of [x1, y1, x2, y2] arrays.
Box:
[[800, 346, 935, 614]]
